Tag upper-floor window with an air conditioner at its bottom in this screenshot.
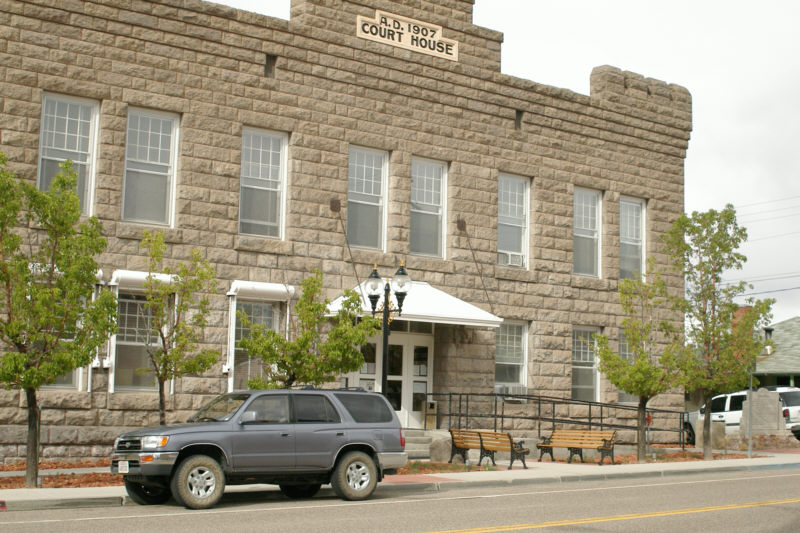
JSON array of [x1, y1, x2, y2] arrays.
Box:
[[497, 174, 530, 268]]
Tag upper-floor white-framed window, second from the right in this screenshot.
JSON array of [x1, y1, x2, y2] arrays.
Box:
[[572, 188, 601, 277]]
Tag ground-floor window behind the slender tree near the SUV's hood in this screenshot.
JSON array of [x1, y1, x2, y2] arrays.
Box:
[[114, 292, 159, 390]]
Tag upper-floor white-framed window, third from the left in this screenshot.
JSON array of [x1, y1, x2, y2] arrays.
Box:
[[239, 129, 289, 239]]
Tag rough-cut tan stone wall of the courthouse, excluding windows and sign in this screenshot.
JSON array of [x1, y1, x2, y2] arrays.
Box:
[[0, 0, 691, 457]]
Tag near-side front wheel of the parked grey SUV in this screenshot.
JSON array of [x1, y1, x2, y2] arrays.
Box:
[[170, 455, 225, 509]]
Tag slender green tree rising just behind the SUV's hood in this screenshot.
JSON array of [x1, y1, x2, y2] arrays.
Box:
[[142, 231, 220, 424]]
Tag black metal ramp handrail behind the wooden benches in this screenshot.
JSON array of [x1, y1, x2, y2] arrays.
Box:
[[424, 392, 687, 448]]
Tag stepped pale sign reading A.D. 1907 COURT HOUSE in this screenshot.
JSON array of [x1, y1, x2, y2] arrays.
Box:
[[356, 11, 458, 61]]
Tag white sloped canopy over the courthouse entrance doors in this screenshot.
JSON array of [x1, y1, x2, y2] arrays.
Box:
[[330, 281, 503, 328]]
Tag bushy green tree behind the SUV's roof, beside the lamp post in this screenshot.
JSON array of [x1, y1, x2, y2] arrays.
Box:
[[239, 270, 379, 389]]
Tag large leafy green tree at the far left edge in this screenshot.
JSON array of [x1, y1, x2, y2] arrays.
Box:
[[0, 153, 117, 487]]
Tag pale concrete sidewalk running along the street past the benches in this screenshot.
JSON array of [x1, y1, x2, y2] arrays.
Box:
[[0, 450, 800, 511]]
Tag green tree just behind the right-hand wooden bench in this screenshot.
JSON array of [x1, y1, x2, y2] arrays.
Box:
[[595, 260, 684, 461]]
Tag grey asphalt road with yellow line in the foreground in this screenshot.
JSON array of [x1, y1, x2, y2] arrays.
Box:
[[0, 469, 800, 533]]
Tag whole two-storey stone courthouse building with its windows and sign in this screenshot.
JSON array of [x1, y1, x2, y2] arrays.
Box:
[[0, 0, 692, 460]]
